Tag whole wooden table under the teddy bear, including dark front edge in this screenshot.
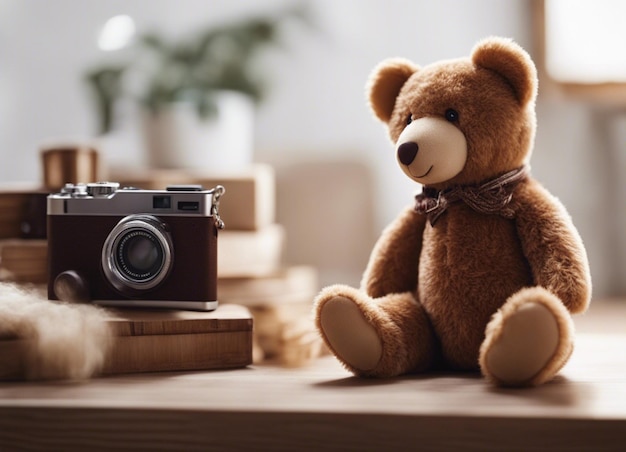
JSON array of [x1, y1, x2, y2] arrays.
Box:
[[0, 302, 626, 451]]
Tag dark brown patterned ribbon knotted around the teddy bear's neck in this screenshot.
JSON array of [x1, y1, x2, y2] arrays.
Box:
[[415, 165, 530, 226]]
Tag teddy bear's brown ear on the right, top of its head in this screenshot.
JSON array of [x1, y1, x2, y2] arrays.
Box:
[[472, 37, 537, 106]]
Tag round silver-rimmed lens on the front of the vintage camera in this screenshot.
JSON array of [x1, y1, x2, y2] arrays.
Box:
[[102, 215, 173, 294]]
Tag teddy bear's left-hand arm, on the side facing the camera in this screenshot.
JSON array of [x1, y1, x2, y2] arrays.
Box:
[[361, 207, 426, 298]]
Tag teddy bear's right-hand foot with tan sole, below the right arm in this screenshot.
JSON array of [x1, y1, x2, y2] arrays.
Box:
[[479, 287, 574, 386]]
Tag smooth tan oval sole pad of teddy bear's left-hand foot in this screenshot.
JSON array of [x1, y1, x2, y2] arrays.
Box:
[[320, 296, 382, 371]]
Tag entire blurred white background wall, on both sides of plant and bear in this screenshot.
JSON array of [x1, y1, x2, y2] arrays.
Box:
[[0, 0, 623, 294]]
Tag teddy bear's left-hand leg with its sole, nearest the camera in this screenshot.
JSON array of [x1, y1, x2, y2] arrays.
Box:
[[315, 285, 436, 377]]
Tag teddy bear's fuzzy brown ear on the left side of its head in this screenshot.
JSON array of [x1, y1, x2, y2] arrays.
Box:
[[367, 58, 419, 122]]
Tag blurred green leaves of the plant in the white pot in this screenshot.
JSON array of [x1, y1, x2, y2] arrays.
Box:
[[87, 6, 307, 133]]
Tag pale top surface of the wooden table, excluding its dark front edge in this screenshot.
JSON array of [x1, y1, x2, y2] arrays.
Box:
[[0, 334, 626, 421]]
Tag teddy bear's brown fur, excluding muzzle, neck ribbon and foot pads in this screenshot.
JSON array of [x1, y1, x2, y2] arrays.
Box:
[[316, 38, 591, 385]]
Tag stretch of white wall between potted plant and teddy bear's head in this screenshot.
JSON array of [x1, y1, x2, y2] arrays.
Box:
[[258, 0, 530, 226]]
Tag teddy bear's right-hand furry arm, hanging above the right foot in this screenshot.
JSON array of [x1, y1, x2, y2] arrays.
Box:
[[515, 180, 591, 313]]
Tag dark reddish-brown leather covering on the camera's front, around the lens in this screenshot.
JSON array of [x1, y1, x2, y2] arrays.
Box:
[[48, 215, 217, 301]]
